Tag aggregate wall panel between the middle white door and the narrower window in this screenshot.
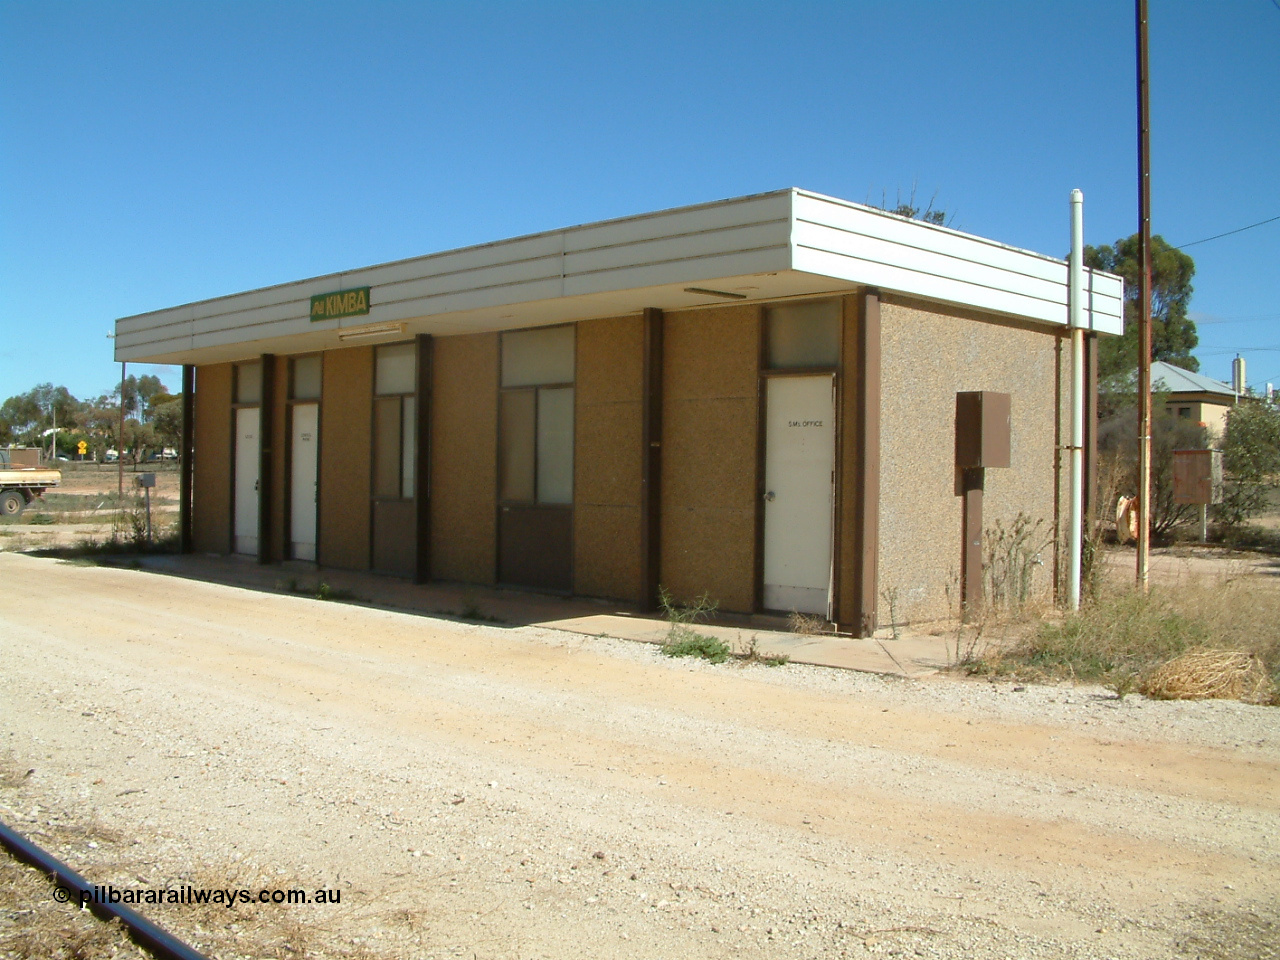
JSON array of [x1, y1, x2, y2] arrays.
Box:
[[319, 347, 374, 570]]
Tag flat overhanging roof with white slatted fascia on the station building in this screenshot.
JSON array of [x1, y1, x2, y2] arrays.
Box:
[[115, 188, 1124, 364]]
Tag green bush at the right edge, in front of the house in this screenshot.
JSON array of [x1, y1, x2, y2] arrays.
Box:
[[1213, 399, 1280, 526]]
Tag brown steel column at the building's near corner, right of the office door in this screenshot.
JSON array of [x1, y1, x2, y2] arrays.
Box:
[[850, 291, 881, 636]]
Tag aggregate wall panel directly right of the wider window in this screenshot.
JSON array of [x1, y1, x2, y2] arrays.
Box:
[[573, 316, 644, 602]]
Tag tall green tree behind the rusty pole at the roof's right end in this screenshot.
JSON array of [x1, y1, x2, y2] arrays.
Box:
[[1084, 233, 1199, 379]]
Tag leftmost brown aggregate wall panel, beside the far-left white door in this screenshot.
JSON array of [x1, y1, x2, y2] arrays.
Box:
[[191, 364, 232, 553]]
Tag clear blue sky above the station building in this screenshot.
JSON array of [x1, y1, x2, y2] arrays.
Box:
[[0, 0, 1280, 398]]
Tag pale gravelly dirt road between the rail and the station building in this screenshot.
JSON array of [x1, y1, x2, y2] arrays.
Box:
[[0, 554, 1280, 960]]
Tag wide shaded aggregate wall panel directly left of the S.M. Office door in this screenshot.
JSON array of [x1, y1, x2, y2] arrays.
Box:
[[660, 306, 760, 612]]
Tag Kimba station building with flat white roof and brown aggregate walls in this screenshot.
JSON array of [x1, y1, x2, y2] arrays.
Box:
[[115, 189, 1123, 635]]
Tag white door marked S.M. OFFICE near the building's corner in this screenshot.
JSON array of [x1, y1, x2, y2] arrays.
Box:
[[764, 374, 836, 617]]
